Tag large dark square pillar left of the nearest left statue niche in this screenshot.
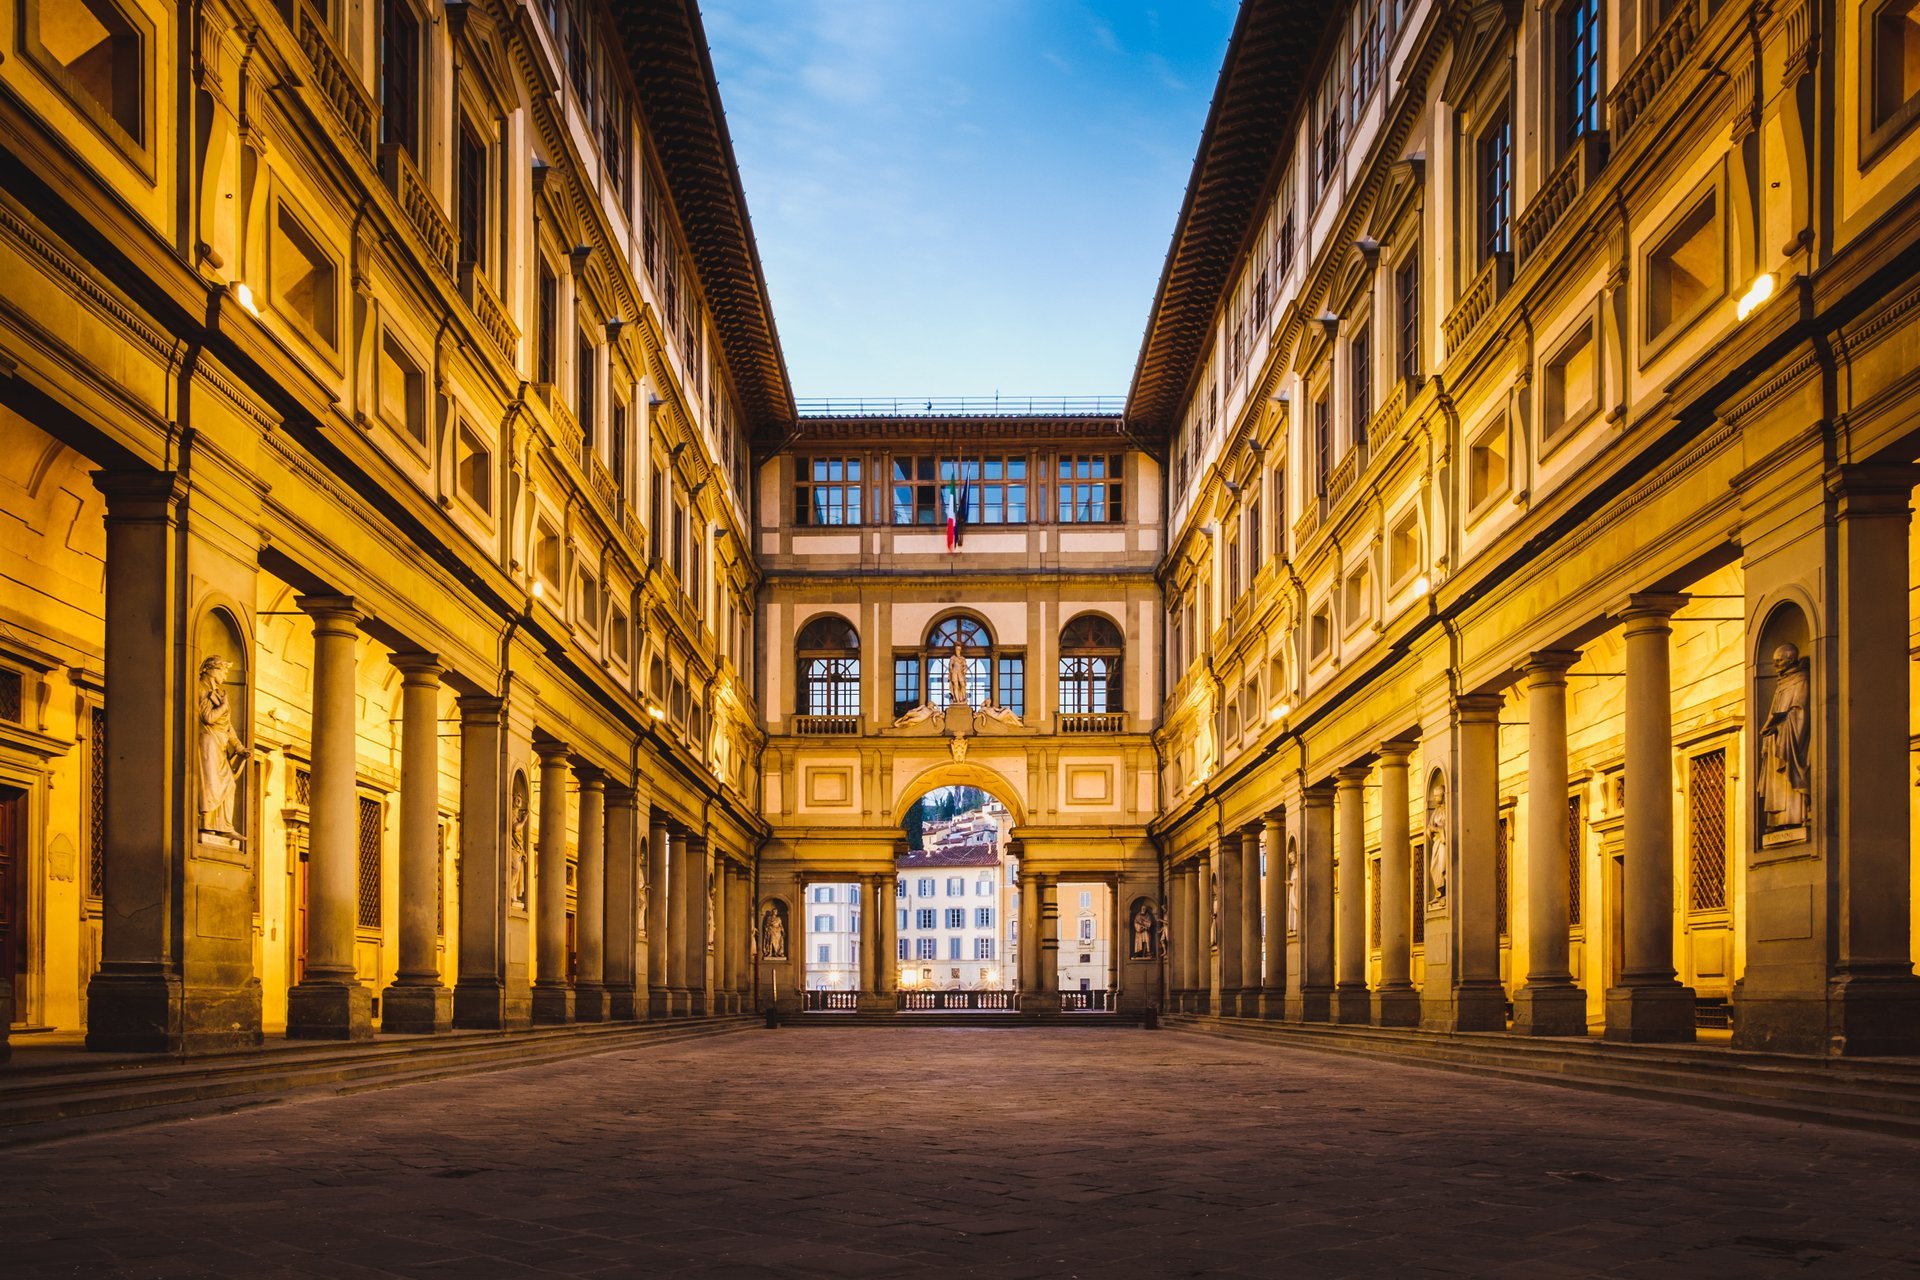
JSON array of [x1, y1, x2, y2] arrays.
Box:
[[84, 472, 187, 1061]]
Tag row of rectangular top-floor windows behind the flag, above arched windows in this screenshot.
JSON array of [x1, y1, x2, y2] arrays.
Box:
[[793, 453, 1125, 528]]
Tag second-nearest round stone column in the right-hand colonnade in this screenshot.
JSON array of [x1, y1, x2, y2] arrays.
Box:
[[1513, 649, 1586, 1036]]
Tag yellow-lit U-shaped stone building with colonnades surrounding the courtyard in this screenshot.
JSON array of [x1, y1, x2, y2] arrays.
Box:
[[0, 0, 1920, 1054]]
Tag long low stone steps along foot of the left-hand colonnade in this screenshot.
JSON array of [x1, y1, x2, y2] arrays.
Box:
[[0, 1015, 758, 1148]]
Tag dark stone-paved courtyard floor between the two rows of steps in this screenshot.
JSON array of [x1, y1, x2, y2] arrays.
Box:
[[0, 1027, 1920, 1278]]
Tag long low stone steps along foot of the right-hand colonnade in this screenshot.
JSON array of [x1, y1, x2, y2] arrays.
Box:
[[1164, 1013, 1920, 1138]]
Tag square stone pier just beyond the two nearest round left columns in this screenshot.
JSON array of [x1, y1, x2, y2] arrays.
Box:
[[453, 697, 507, 1031]]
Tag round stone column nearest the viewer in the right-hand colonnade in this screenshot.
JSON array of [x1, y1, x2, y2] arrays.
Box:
[[1607, 595, 1697, 1044]]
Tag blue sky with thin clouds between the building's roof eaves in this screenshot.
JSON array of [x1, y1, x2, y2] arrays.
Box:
[[701, 0, 1235, 397]]
